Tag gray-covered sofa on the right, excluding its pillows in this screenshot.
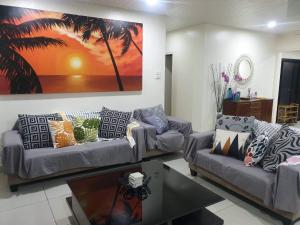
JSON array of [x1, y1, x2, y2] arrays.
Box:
[[184, 132, 300, 224]]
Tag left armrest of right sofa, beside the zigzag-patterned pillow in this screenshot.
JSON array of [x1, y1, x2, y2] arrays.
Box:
[[184, 131, 215, 163]]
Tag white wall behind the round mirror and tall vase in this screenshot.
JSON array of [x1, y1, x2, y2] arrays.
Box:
[[167, 25, 276, 131]]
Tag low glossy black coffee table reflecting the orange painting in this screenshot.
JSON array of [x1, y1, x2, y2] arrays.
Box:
[[66, 160, 224, 225]]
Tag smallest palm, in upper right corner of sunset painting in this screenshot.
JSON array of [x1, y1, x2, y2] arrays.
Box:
[[109, 21, 143, 55]]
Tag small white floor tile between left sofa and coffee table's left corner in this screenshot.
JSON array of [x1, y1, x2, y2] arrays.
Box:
[[43, 179, 72, 199]]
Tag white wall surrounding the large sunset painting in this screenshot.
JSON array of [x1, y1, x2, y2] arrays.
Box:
[[0, 0, 166, 137]]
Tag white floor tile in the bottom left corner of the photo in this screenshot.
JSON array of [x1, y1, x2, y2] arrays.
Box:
[[0, 201, 55, 225]]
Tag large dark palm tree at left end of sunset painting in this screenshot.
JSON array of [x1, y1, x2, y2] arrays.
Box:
[[0, 6, 65, 94]]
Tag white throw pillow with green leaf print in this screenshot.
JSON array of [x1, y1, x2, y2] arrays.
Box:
[[74, 117, 100, 143]]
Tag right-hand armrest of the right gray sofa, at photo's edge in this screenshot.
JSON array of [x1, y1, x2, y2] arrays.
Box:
[[273, 165, 300, 213]]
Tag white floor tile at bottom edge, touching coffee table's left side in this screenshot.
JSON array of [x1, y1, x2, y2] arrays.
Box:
[[49, 196, 76, 225]]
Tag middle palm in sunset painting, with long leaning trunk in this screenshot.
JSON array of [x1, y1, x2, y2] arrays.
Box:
[[62, 14, 124, 91]]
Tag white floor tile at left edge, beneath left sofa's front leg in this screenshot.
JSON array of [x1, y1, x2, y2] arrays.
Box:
[[0, 184, 47, 211]]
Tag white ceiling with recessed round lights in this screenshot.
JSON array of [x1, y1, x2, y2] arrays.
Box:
[[76, 0, 300, 33]]
